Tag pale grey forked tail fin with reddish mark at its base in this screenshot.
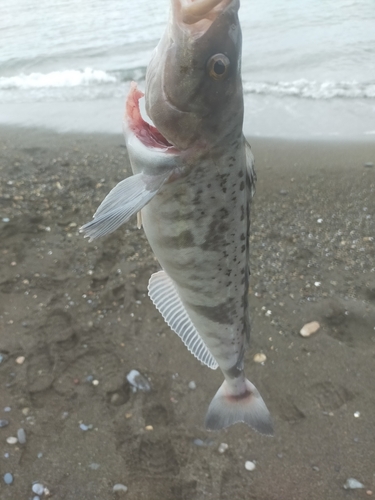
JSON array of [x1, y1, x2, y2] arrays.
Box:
[[205, 379, 273, 436]]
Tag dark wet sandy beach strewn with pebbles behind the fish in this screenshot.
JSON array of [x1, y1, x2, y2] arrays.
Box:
[[0, 127, 375, 500]]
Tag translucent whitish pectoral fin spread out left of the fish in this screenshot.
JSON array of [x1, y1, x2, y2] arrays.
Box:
[[80, 172, 170, 241]]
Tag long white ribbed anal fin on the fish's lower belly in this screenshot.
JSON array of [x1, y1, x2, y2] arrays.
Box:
[[148, 271, 218, 370]]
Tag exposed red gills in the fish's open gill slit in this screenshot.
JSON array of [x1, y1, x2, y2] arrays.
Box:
[[126, 82, 178, 153]]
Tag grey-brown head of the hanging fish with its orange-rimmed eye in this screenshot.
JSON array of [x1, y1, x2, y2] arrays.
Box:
[[145, 0, 243, 151]]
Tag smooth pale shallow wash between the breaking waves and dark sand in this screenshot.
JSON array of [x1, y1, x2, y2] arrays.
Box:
[[0, 89, 375, 140]]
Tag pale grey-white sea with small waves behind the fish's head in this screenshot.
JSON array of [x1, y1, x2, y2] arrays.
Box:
[[0, 0, 375, 141]]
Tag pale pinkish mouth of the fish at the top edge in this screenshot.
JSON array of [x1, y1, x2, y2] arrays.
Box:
[[172, 0, 233, 32]]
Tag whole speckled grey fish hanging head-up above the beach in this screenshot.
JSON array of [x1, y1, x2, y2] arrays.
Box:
[[81, 0, 273, 435]]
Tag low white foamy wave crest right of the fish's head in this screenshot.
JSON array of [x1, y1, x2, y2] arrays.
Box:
[[244, 79, 375, 99]]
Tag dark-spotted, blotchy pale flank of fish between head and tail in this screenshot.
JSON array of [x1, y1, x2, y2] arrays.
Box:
[[142, 141, 250, 370]]
